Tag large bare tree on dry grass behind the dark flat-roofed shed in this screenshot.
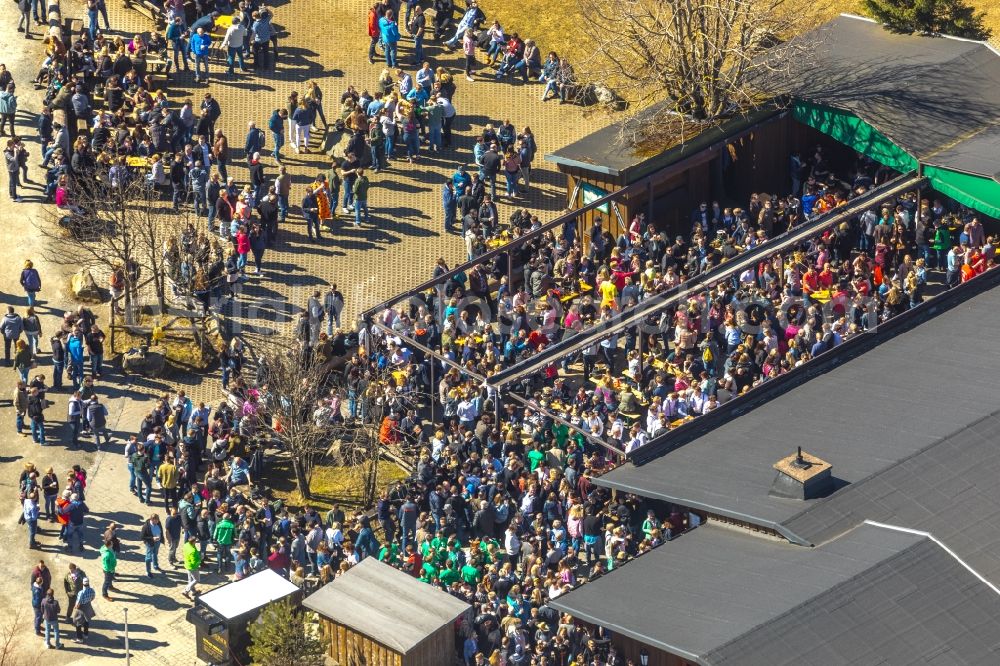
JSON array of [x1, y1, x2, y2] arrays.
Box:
[[580, 0, 818, 145]]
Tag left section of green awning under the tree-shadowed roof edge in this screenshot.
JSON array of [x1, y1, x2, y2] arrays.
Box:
[[792, 101, 917, 173]]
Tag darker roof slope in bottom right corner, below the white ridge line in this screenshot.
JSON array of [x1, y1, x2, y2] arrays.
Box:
[[704, 539, 1000, 666]]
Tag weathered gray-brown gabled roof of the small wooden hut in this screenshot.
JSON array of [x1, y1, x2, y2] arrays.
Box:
[[302, 557, 470, 654]]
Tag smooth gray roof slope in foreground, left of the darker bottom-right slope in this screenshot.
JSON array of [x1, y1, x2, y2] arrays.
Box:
[[549, 523, 921, 659]]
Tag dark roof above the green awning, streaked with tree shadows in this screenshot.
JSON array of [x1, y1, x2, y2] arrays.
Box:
[[768, 16, 1000, 170]]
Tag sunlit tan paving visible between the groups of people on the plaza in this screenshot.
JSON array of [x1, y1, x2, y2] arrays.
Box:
[[0, 0, 606, 664]]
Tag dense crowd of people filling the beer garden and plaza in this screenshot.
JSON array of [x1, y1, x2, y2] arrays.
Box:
[[7, 0, 996, 666]]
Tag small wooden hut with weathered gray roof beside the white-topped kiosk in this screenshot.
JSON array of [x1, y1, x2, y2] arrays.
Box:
[[302, 557, 471, 666]]
